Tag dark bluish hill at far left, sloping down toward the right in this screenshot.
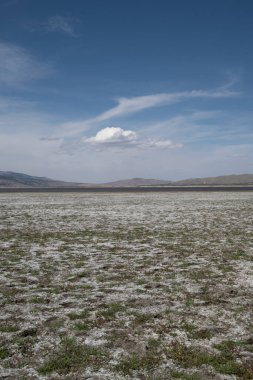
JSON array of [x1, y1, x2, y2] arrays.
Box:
[[0, 171, 80, 188]]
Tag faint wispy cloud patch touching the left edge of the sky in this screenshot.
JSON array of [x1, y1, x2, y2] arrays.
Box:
[[0, 42, 52, 87]]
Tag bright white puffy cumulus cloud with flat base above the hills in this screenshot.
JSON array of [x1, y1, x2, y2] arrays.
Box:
[[81, 127, 182, 149]]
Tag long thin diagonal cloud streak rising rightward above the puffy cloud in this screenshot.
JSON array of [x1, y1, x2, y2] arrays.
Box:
[[62, 89, 238, 135]]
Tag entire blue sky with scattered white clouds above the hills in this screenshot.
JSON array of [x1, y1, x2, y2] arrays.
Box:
[[0, 0, 253, 183]]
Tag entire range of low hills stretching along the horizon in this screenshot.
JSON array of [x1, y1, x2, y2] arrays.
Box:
[[0, 171, 253, 188]]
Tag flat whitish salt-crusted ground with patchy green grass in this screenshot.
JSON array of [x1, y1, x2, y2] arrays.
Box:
[[0, 191, 253, 380]]
